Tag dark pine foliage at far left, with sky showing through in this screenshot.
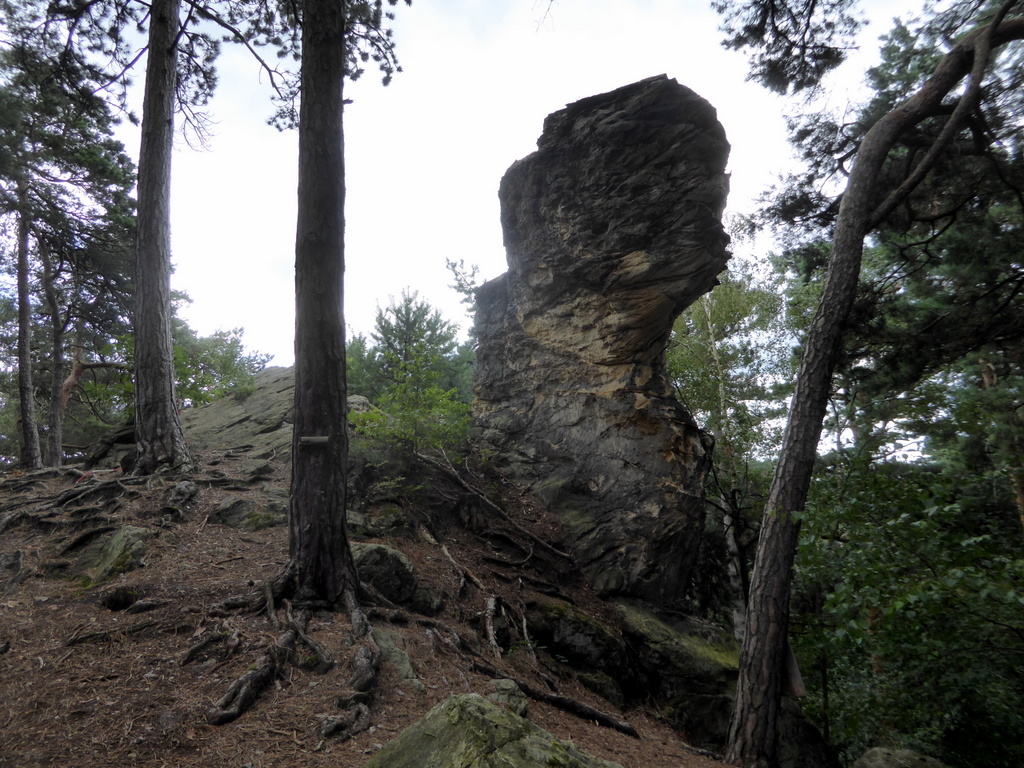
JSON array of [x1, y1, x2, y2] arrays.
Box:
[[0, 16, 135, 464]]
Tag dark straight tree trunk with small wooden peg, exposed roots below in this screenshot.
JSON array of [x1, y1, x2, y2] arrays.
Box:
[[289, 0, 358, 605]]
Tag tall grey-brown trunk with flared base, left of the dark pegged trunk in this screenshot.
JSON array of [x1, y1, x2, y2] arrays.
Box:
[[134, 0, 194, 474]]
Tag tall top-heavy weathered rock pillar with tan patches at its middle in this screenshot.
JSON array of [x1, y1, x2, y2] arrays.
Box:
[[474, 76, 729, 605]]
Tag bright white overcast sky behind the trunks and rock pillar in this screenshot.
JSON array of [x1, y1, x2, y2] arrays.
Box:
[[157, 0, 913, 365]]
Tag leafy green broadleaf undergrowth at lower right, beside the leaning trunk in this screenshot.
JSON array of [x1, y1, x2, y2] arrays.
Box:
[[795, 460, 1024, 768]]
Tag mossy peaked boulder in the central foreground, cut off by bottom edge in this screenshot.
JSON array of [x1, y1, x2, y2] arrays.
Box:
[[364, 694, 622, 768]]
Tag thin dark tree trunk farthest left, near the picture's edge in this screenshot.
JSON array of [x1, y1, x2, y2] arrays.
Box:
[[17, 181, 43, 469]]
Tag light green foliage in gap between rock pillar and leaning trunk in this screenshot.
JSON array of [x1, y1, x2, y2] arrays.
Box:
[[666, 264, 795, 621]]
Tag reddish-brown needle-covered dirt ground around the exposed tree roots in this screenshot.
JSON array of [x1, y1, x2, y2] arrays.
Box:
[[0, 448, 722, 768]]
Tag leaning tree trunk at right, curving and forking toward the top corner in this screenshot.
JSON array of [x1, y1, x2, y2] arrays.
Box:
[[726, 13, 1024, 768]]
